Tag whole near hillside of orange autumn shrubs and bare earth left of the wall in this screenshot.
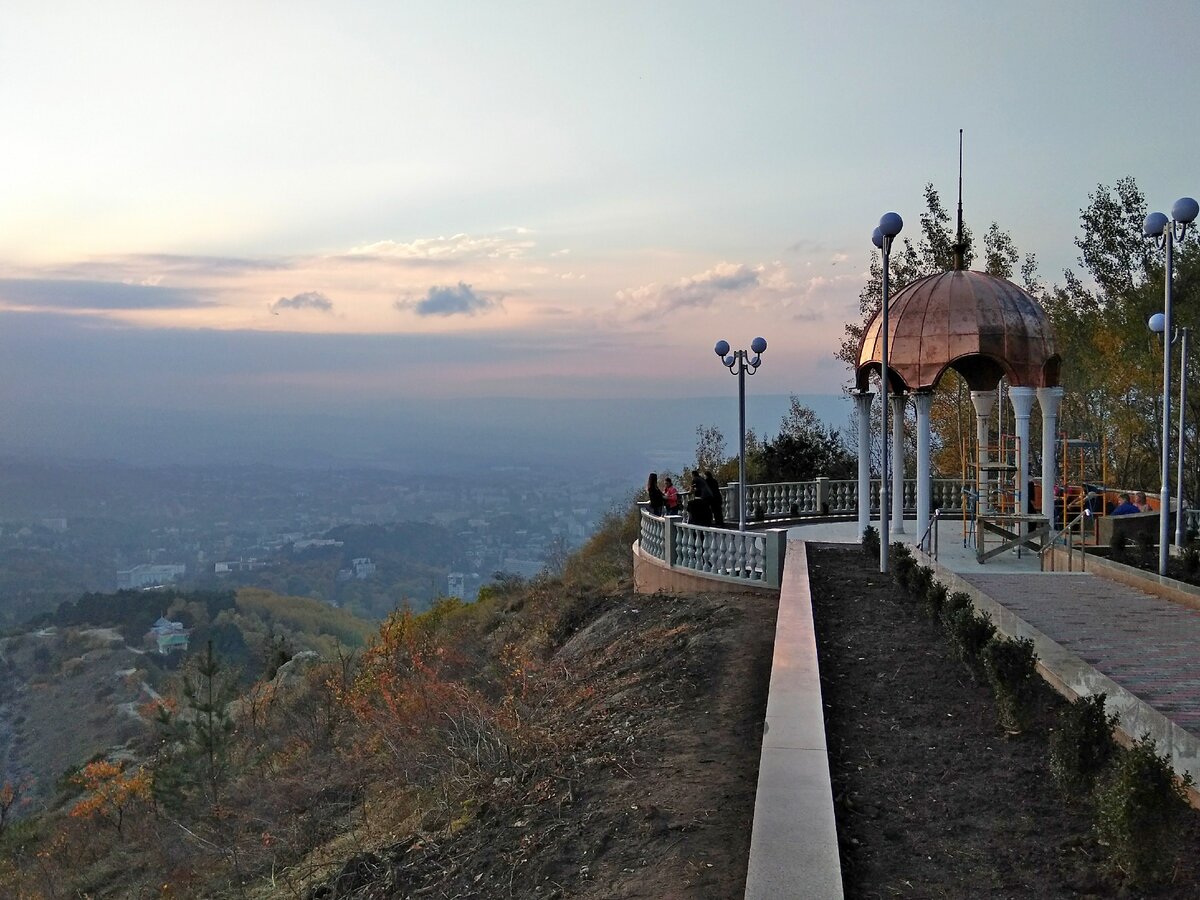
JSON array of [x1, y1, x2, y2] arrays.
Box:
[[0, 508, 774, 900]]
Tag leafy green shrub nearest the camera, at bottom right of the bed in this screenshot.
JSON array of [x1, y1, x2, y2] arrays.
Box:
[[1096, 734, 1192, 886]]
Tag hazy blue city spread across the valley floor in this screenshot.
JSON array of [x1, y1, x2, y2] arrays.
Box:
[[0, 460, 631, 626]]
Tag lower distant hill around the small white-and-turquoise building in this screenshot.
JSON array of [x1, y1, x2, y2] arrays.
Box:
[[0, 588, 373, 815]]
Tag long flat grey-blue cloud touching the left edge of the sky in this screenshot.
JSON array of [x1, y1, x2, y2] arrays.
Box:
[[0, 278, 210, 311]]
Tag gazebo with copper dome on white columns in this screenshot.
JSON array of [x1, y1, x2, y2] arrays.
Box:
[[854, 268, 1062, 535]]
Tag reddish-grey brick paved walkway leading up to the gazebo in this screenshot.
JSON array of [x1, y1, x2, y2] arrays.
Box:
[[959, 578, 1200, 737]]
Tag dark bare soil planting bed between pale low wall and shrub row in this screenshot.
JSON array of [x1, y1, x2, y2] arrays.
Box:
[[809, 544, 1200, 900]]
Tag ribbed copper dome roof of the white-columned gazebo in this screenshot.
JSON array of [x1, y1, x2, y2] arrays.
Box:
[[856, 270, 1061, 391]]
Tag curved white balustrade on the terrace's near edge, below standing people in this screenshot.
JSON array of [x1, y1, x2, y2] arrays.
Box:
[[638, 508, 787, 589]]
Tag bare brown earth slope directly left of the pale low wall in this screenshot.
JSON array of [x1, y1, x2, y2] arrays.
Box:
[[308, 593, 776, 900]]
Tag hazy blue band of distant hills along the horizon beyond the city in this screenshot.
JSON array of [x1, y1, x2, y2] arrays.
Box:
[[0, 391, 853, 490]]
